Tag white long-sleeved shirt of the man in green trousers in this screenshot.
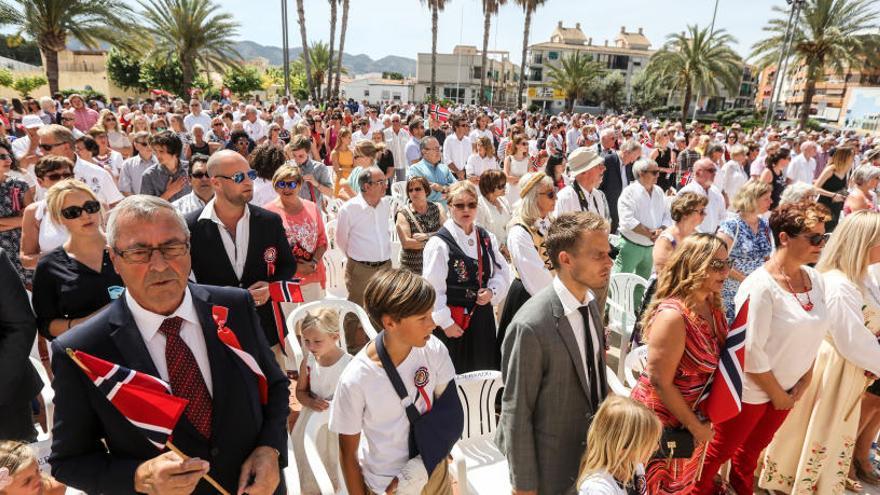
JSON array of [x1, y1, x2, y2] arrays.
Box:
[[617, 181, 672, 246]]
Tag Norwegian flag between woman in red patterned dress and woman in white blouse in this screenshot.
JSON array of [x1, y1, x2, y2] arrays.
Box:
[[705, 299, 749, 424]]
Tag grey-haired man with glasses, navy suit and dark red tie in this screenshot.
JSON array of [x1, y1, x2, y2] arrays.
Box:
[[49, 195, 289, 495]]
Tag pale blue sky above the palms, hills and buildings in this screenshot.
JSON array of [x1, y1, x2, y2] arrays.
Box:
[[144, 0, 786, 62]]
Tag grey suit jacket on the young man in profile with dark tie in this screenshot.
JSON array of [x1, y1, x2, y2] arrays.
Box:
[[495, 284, 608, 495]]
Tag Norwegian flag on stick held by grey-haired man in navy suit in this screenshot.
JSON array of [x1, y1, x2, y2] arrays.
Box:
[[67, 349, 188, 450]]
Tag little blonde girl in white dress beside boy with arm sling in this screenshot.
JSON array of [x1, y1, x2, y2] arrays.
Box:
[[293, 308, 352, 495]]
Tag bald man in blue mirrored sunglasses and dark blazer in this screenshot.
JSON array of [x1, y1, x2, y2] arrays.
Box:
[[186, 150, 296, 364]]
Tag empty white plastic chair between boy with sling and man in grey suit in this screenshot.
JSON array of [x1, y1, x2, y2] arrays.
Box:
[[450, 371, 511, 495]]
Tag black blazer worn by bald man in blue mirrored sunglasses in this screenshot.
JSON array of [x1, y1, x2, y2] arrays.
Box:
[[186, 204, 296, 346]]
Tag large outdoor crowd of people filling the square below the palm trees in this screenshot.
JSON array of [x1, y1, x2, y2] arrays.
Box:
[[0, 90, 880, 495]]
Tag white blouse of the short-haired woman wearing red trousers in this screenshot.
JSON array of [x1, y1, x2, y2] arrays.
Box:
[[731, 266, 832, 404]]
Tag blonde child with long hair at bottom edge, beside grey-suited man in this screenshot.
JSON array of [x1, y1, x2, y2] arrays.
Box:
[[577, 395, 663, 495]]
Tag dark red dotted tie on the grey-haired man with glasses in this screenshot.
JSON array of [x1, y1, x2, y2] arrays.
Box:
[[159, 316, 213, 438]]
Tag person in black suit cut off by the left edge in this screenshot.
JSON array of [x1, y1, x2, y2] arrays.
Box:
[[0, 249, 42, 441]]
